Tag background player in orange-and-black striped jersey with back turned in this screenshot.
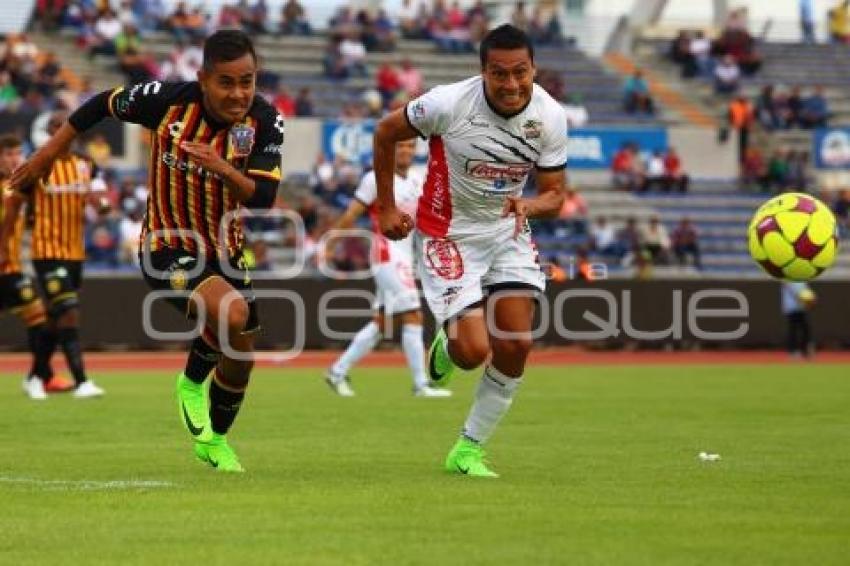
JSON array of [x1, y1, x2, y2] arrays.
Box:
[[3, 118, 104, 399]]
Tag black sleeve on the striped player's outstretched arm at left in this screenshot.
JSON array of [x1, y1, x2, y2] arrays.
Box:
[[69, 81, 191, 132]]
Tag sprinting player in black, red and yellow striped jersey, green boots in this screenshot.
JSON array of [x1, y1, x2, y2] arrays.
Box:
[[7, 30, 284, 472]]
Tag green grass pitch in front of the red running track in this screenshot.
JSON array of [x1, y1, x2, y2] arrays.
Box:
[[0, 365, 850, 566]]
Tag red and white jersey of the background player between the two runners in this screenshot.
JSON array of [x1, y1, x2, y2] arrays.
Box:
[[354, 170, 422, 263]]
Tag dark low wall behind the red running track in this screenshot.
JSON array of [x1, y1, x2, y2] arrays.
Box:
[[0, 277, 850, 351]]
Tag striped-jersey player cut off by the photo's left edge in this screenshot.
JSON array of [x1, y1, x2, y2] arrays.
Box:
[[0, 134, 60, 400]]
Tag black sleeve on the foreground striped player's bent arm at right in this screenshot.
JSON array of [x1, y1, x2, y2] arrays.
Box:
[[245, 107, 284, 208]]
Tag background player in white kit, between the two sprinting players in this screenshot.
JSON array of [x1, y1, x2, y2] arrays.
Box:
[[325, 139, 451, 397]]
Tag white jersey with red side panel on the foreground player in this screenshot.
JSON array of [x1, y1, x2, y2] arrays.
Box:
[[405, 75, 567, 237]]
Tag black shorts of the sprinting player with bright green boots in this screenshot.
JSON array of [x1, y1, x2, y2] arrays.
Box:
[[139, 248, 260, 332]]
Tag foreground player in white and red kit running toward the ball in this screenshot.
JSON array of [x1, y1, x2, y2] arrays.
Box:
[[374, 25, 567, 477]]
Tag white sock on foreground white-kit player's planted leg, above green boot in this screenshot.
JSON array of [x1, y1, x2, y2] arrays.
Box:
[[463, 366, 522, 444]]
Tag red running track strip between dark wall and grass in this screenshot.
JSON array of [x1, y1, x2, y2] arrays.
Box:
[[0, 348, 850, 374]]
